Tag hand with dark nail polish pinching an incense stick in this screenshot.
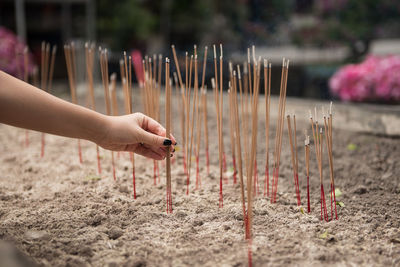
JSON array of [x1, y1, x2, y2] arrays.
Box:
[[94, 113, 176, 160]]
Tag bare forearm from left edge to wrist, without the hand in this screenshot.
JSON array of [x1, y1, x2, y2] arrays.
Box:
[[0, 71, 107, 141]]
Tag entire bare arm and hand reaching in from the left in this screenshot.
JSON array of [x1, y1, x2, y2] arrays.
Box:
[[0, 71, 176, 160]]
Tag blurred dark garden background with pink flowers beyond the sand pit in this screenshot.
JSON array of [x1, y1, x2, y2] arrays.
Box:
[[0, 0, 400, 104]]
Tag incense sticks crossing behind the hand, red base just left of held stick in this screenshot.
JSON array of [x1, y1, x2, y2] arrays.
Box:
[[119, 52, 136, 199]]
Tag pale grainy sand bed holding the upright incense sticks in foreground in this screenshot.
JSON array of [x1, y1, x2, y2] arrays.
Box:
[[0, 98, 400, 266]]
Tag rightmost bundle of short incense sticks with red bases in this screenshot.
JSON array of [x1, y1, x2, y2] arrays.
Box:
[[324, 102, 338, 220]]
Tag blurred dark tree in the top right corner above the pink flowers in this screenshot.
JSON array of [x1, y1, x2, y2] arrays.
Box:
[[292, 0, 400, 61]]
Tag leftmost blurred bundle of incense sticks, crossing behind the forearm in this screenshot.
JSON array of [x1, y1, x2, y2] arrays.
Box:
[[39, 42, 57, 158]]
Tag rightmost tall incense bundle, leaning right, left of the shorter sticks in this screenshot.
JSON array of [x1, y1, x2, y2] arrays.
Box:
[[271, 59, 289, 203]]
